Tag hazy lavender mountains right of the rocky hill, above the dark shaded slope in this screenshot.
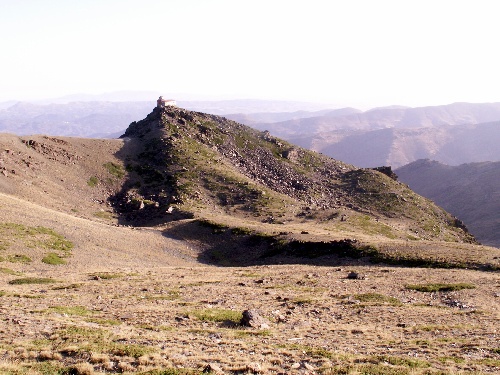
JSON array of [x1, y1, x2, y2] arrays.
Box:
[[226, 103, 500, 167]]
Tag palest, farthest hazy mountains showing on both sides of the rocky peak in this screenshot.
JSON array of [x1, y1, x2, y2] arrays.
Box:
[[0, 98, 336, 138]]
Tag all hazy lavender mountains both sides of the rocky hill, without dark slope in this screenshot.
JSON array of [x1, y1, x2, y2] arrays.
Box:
[[0, 98, 500, 168]]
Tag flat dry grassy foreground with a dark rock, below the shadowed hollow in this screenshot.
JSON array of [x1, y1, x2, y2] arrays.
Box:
[[0, 264, 500, 374]]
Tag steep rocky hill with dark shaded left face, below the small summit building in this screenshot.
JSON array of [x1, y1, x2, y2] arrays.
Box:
[[108, 108, 470, 247]]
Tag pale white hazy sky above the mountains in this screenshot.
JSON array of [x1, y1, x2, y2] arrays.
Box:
[[0, 0, 500, 108]]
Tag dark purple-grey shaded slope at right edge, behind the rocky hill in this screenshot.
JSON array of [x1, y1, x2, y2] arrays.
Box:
[[396, 160, 500, 247]]
